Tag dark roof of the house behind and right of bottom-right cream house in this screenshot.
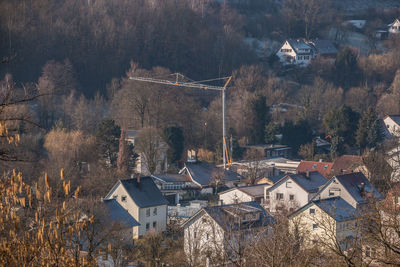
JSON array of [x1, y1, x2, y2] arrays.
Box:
[[332, 172, 383, 203]]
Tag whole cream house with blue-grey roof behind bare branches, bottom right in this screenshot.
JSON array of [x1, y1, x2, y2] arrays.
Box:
[[289, 196, 359, 250]]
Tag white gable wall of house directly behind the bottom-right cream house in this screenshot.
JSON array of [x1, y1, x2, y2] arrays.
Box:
[[265, 176, 314, 212]]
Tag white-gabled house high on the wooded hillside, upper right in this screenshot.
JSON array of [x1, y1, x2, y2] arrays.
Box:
[[276, 41, 313, 66]]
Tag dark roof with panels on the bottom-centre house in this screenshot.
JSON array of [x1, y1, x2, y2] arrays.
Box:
[[203, 201, 274, 231]]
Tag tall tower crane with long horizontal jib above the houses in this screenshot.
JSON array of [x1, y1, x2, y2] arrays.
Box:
[[129, 73, 232, 169]]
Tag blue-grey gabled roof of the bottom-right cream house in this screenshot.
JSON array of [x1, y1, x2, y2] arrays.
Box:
[[290, 196, 359, 222]]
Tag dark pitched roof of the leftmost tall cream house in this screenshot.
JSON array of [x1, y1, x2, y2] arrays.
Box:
[[105, 176, 168, 208]]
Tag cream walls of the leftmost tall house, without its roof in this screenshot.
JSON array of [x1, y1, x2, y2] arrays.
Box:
[[106, 183, 167, 239]]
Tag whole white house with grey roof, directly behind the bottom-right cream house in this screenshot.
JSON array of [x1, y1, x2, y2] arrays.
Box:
[[265, 171, 328, 212]]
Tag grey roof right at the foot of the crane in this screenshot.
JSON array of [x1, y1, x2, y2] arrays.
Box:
[[185, 161, 244, 186]]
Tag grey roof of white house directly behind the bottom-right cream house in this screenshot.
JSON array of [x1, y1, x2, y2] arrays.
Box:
[[268, 171, 328, 193]]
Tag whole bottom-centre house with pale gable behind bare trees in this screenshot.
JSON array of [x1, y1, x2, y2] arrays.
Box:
[[183, 202, 274, 266]]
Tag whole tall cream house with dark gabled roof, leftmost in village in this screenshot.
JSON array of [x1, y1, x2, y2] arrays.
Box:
[[104, 176, 168, 239]]
